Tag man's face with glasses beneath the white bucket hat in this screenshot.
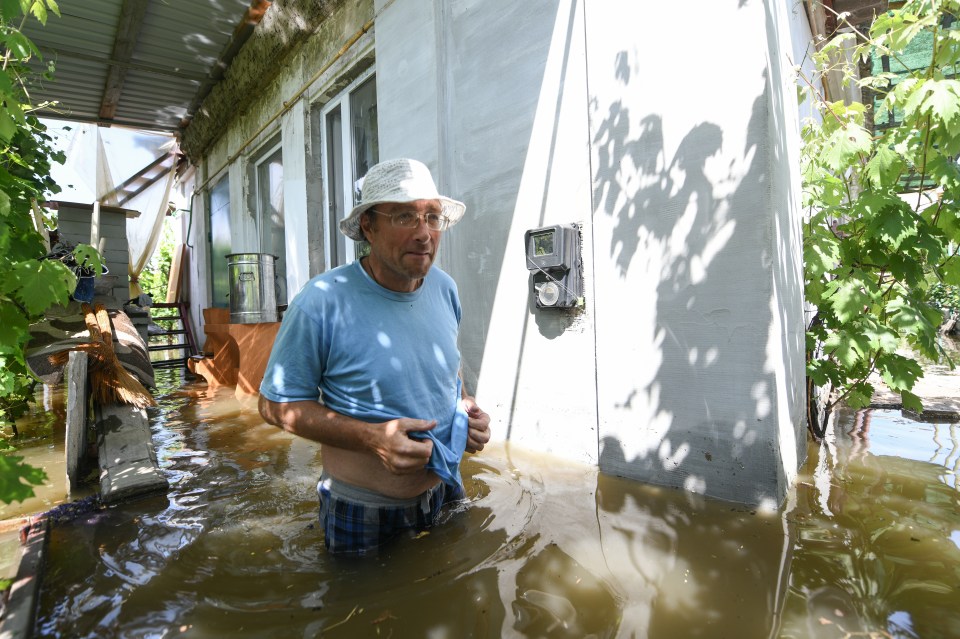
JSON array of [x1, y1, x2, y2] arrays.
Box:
[[360, 200, 442, 292]]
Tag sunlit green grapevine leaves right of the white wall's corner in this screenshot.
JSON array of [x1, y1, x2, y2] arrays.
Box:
[[802, 0, 960, 430]]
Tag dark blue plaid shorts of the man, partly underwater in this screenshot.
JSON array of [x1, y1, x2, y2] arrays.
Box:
[[317, 473, 464, 556]]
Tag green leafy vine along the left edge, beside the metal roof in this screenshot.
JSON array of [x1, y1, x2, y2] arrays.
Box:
[[0, 0, 100, 503]]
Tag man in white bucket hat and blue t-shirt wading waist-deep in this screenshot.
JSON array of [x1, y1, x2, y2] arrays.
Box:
[[260, 159, 490, 555]]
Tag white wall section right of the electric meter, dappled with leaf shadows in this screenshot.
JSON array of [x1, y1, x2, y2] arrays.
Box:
[[587, 0, 803, 503]]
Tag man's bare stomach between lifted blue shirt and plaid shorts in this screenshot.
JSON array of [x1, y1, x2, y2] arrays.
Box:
[[320, 444, 440, 499]]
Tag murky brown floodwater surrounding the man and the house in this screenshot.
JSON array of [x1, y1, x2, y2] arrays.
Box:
[[0, 371, 960, 639]]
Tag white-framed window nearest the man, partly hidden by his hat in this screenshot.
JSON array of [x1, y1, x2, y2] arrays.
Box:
[[321, 69, 380, 268]]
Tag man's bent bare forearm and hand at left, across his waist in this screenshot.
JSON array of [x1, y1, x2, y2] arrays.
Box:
[[259, 395, 437, 475]]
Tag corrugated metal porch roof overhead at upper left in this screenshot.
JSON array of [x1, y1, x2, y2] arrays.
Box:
[[24, 0, 271, 131]]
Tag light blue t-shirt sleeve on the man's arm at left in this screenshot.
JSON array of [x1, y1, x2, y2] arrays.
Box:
[[260, 305, 323, 402]]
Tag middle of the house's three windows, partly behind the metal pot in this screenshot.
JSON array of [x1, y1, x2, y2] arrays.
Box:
[[254, 144, 287, 305]]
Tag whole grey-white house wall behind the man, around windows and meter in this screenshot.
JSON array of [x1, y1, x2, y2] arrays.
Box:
[[182, 0, 805, 504]]
